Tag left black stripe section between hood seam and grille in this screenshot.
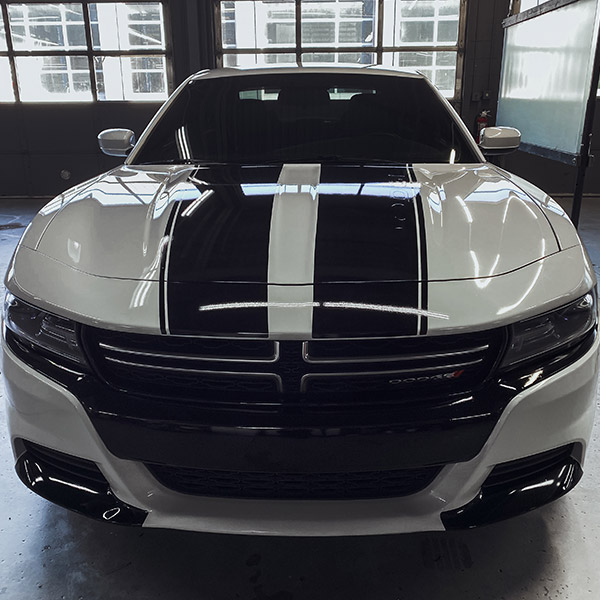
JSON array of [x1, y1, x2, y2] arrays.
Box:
[[167, 282, 268, 337]]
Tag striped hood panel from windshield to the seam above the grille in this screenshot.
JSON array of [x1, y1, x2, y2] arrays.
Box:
[[32, 164, 560, 285]]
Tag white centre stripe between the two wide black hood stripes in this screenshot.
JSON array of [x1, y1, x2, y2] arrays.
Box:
[[267, 164, 321, 338]]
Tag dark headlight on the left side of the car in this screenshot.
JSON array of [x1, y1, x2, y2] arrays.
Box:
[[4, 292, 87, 365]]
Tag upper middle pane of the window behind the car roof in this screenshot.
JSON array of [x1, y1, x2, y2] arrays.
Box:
[[302, 0, 377, 47]]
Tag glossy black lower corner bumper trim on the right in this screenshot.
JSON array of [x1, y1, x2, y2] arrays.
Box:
[[441, 444, 583, 529]]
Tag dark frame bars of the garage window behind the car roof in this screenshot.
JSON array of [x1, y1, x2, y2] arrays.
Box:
[[213, 0, 468, 105]]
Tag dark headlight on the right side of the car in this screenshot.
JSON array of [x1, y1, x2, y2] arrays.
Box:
[[501, 290, 597, 367]]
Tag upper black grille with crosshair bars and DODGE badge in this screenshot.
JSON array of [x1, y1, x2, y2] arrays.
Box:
[[82, 327, 504, 403]]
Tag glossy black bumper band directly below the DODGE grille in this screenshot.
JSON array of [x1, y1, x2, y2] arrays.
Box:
[[7, 316, 596, 480]]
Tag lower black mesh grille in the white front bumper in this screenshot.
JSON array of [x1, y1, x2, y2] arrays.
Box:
[[146, 464, 442, 500]]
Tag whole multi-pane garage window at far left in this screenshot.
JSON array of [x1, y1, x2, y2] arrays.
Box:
[[0, 2, 168, 102]]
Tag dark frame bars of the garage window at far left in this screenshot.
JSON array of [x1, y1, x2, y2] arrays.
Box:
[[0, 0, 174, 104]]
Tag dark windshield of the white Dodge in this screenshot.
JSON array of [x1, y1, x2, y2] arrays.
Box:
[[135, 72, 479, 164]]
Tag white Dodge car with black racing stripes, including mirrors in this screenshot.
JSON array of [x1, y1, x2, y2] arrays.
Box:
[[3, 68, 598, 535]]
